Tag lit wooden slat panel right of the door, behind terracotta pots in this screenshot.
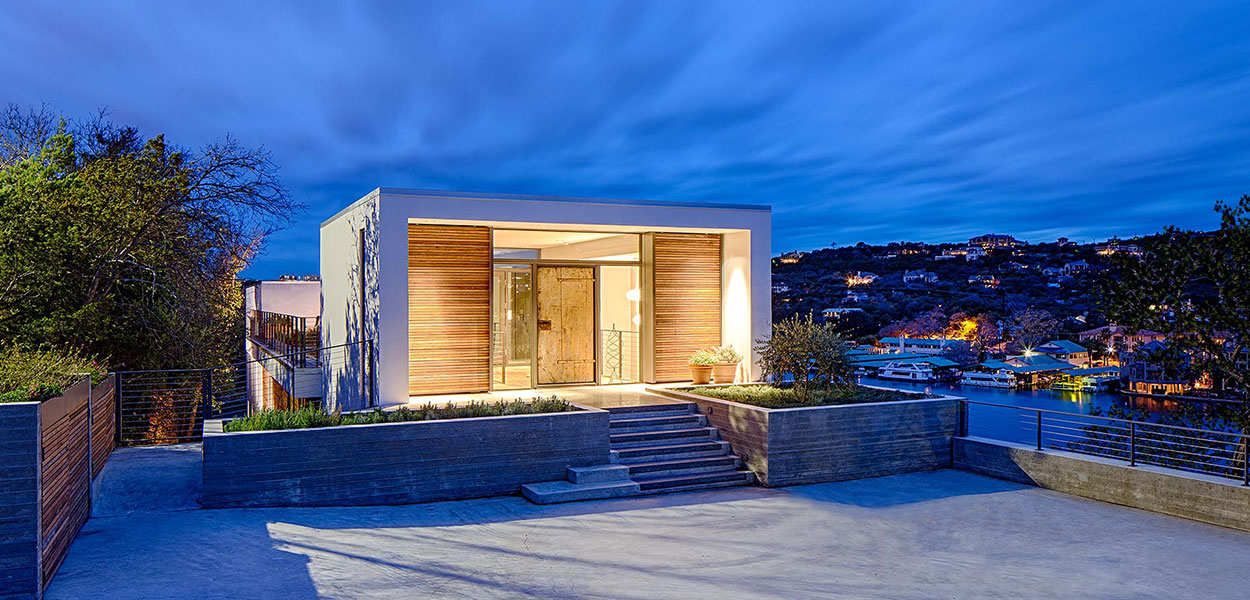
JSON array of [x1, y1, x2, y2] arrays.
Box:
[[653, 234, 721, 383]]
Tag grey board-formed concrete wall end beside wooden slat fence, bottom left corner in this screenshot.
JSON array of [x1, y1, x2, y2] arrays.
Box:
[[0, 403, 43, 600]]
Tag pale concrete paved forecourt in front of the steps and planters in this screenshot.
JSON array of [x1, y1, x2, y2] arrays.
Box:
[[46, 470, 1250, 600]]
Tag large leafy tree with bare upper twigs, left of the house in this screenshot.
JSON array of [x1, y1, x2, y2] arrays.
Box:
[[0, 106, 300, 368]]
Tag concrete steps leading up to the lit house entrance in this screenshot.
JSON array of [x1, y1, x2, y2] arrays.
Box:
[[521, 403, 755, 504]]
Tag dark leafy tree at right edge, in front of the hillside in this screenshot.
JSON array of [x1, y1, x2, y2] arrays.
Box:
[[1099, 196, 1250, 420]]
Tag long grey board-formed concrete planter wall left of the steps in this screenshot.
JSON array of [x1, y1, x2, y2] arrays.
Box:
[[201, 409, 609, 508]]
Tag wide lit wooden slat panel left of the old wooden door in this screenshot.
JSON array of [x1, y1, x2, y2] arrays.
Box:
[[408, 225, 491, 395]]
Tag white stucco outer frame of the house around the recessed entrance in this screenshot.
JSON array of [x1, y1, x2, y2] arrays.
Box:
[[321, 188, 771, 405]]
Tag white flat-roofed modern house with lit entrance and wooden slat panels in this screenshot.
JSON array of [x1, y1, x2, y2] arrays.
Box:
[[320, 188, 771, 409]]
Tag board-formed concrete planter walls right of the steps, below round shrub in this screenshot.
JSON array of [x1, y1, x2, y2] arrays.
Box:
[[650, 384, 959, 488]]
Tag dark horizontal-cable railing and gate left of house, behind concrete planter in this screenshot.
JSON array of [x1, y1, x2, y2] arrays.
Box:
[[113, 340, 376, 445]]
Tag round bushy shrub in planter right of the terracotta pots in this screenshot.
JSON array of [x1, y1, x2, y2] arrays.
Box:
[[755, 315, 855, 404]]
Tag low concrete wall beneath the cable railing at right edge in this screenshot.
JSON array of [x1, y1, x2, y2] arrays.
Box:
[[954, 438, 1250, 531]]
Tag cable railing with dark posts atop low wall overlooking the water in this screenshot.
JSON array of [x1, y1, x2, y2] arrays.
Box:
[[960, 400, 1250, 486]]
